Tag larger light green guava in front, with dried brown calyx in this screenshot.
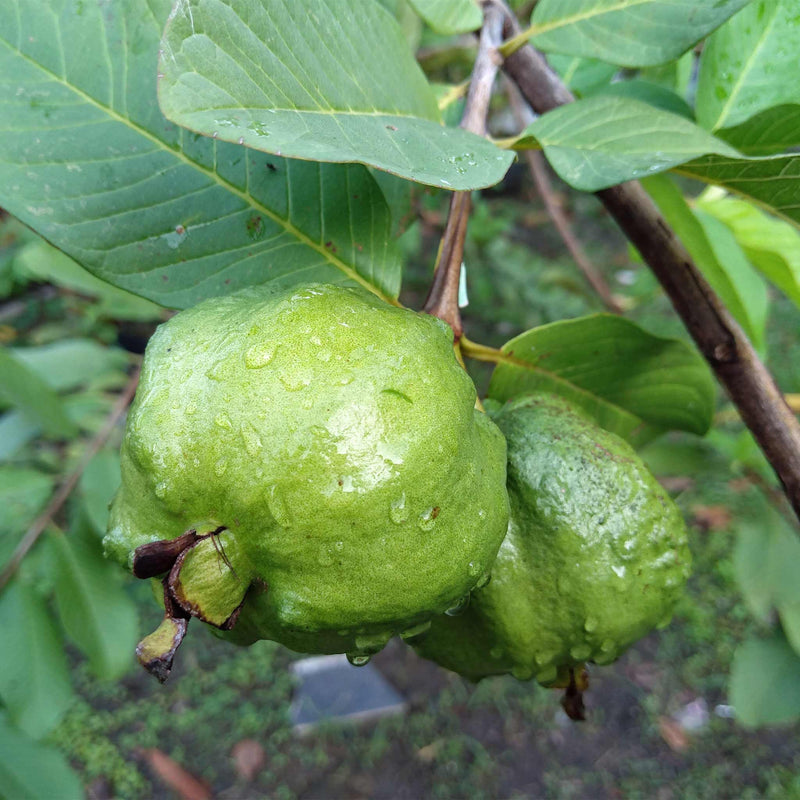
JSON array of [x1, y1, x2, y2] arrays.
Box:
[[105, 284, 508, 677]]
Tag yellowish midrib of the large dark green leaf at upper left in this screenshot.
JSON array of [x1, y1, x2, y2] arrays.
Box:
[[0, 34, 399, 306]]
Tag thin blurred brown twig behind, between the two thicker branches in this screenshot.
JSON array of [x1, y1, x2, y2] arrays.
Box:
[[508, 81, 622, 314]]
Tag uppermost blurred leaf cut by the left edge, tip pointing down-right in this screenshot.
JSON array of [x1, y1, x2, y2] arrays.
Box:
[[0, 346, 78, 438]]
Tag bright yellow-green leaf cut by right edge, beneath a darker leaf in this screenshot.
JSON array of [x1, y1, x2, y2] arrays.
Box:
[[696, 190, 800, 307]]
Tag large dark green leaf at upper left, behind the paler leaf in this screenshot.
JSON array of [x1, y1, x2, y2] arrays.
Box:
[[0, 0, 400, 307]]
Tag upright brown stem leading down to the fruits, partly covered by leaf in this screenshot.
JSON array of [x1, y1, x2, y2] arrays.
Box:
[[423, 3, 503, 342]]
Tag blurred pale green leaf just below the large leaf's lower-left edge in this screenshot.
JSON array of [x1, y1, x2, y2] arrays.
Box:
[[14, 240, 163, 320]]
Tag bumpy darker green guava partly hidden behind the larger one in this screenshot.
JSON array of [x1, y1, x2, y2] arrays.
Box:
[[412, 394, 690, 689]]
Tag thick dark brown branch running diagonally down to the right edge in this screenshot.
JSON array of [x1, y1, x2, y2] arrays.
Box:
[[503, 10, 800, 518]]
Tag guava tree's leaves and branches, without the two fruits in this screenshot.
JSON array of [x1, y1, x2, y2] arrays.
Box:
[[0, 0, 800, 796]]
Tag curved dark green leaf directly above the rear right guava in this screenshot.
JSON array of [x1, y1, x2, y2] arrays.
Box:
[[489, 314, 715, 443]]
